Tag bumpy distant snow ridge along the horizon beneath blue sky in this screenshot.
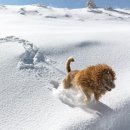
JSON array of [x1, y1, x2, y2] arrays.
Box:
[[0, 4, 130, 21]]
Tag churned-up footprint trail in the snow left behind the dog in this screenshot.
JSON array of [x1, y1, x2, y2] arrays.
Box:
[[0, 36, 64, 76]]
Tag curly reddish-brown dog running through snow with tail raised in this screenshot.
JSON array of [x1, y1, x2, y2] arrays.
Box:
[[63, 57, 115, 101]]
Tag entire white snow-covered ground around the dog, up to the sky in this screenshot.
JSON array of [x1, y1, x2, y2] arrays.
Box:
[[0, 5, 130, 130]]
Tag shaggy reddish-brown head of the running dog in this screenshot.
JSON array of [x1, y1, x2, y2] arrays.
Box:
[[98, 65, 116, 91]]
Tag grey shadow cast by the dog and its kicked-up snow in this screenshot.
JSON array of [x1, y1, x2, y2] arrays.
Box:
[[50, 80, 114, 116]]
